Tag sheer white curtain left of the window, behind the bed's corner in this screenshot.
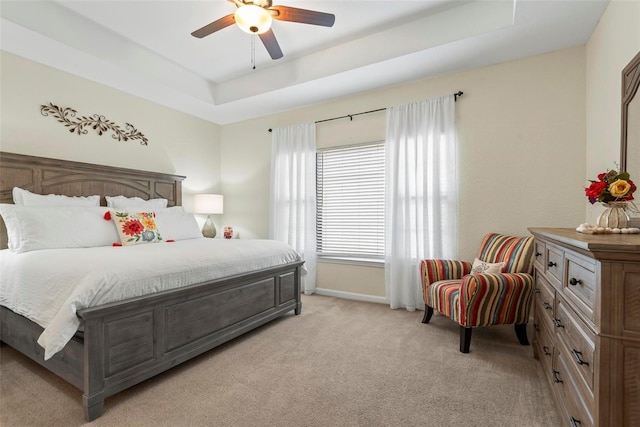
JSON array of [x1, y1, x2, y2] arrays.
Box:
[[269, 123, 317, 294]]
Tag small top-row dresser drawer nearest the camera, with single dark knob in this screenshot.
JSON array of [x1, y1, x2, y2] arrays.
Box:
[[563, 254, 597, 322]]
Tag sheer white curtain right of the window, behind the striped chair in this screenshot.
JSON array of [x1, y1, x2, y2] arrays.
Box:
[[385, 95, 458, 311]]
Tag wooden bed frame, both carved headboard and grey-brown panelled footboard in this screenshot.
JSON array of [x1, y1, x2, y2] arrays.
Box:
[[0, 152, 303, 421]]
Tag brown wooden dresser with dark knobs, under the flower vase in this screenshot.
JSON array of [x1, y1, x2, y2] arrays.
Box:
[[529, 228, 640, 427]]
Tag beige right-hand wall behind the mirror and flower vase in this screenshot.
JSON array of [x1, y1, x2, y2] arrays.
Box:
[[584, 0, 640, 223]]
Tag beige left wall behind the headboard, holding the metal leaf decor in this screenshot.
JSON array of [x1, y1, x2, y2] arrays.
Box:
[[0, 52, 221, 222]]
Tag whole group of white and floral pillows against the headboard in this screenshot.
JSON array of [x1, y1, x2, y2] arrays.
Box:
[[0, 187, 203, 253]]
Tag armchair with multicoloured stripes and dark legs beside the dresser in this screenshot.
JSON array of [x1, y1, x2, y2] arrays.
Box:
[[420, 233, 533, 353]]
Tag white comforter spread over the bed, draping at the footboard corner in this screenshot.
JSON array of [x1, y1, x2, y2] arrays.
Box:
[[0, 238, 301, 360]]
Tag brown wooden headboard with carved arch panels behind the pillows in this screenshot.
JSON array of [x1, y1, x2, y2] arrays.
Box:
[[0, 152, 185, 248]]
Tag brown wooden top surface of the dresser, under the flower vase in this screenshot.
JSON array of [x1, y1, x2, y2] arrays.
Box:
[[529, 227, 640, 261]]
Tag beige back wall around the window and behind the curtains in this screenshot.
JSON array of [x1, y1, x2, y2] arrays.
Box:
[[220, 47, 585, 299]]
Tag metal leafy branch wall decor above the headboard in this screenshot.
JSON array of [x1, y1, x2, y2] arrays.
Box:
[[40, 102, 149, 145]]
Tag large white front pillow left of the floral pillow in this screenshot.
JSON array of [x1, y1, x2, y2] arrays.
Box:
[[0, 204, 120, 253]]
